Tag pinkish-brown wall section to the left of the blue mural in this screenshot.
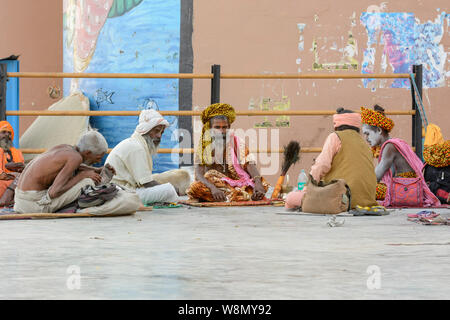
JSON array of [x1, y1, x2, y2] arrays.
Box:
[[0, 0, 63, 134]]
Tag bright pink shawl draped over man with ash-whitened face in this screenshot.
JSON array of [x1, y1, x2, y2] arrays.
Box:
[[378, 138, 441, 207]]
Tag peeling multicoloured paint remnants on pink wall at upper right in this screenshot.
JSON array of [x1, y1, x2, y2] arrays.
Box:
[[296, 10, 450, 91]]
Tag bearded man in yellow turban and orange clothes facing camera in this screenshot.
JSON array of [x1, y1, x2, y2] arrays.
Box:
[[187, 103, 269, 201]]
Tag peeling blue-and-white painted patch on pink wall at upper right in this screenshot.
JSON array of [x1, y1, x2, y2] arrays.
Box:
[[360, 12, 449, 90]]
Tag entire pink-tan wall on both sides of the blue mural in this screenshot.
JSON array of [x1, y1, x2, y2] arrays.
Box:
[[0, 0, 450, 183]]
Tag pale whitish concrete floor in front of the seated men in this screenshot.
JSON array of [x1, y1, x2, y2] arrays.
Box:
[[0, 207, 450, 299]]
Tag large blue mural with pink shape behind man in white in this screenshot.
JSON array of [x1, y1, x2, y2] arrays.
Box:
[[64, 0, 180, 172]]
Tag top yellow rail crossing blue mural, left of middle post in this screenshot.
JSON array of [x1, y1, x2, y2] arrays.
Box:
[[7, 72, 213, 79]]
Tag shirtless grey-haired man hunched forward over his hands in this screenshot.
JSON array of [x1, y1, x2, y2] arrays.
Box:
[[14, 131, 140, 215]]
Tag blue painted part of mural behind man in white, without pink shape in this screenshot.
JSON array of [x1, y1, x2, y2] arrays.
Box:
[[64, 0, 180, 172]]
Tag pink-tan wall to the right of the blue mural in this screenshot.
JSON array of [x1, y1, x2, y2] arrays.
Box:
[[193, 0, 450, 184]]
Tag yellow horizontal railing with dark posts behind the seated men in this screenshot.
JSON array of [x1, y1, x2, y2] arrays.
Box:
[[0, 65, 422, 158]]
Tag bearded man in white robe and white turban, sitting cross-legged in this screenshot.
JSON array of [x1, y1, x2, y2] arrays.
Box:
[[105, 109, 190, 204]]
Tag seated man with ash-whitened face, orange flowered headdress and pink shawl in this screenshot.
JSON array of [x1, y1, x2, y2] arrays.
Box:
[[361, 105, 440, 207]]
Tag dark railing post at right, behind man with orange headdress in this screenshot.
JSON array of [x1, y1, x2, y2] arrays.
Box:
[[411, 64, 423, 160]]
